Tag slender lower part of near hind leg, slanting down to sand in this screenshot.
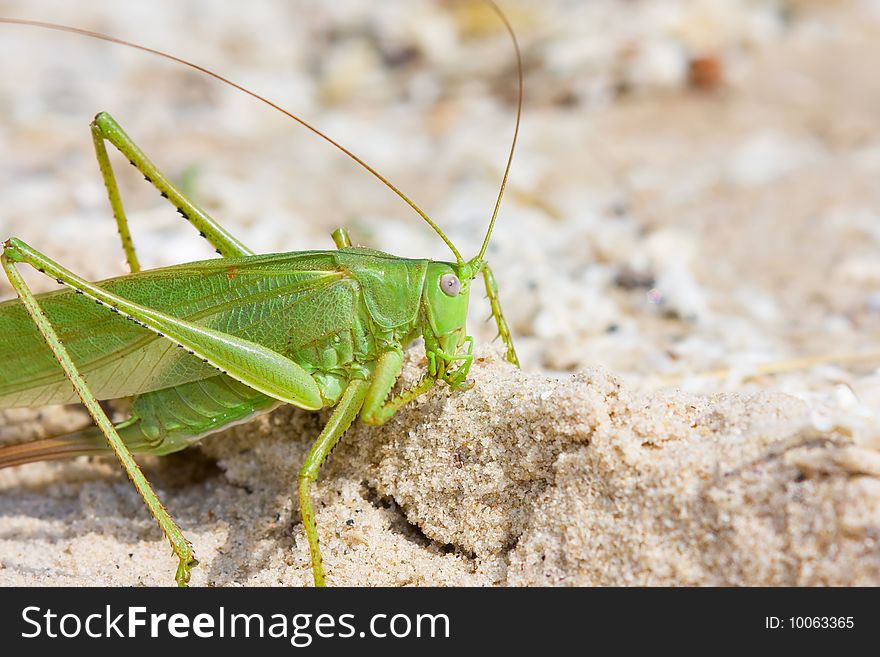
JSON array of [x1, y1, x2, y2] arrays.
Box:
[[0, 242, 199, 586]]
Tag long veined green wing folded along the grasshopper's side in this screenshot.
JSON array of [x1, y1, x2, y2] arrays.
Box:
[[0, 251, 359, 408]]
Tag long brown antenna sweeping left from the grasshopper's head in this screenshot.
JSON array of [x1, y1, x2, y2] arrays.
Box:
[[0, 16, 468, 262]]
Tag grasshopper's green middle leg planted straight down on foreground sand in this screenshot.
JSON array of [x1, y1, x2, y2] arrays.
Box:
[[299, 379, 370, 586]]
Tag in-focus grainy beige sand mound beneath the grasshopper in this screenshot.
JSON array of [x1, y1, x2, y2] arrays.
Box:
[[0, 352, 880, 585]]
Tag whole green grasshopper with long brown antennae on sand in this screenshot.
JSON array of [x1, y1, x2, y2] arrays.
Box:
[[0, 2, 523, 586]]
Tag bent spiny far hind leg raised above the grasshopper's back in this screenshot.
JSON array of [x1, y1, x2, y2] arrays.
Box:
[[90, 112, 253, 272]]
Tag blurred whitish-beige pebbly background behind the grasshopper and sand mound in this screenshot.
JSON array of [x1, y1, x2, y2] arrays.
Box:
[[0, 0, 880, 421]]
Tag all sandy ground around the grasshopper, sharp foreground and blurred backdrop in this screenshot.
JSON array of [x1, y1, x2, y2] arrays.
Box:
[[0, 0, 880, 586]]
